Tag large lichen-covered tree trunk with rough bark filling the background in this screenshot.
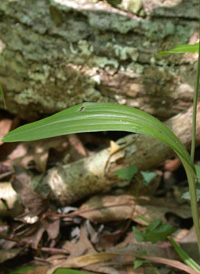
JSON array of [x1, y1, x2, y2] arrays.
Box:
[[0, 0, 199, 120]]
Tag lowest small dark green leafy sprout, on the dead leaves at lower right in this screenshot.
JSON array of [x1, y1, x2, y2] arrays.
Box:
[[133, 220, 176, 244]]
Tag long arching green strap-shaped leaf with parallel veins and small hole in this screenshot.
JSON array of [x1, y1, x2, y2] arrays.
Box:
[[2, 103, 200, 248]]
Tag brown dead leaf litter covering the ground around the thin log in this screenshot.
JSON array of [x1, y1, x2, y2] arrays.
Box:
[[0, 113, 200, 274]]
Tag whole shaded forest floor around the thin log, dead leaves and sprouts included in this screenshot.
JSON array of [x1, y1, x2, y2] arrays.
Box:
[[0, 107, 200, 274]]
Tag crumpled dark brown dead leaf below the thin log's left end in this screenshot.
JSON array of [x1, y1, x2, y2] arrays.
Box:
[[12, 168, 60, 248]]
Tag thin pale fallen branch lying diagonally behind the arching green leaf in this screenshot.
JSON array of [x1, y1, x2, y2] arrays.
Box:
[[0, 103, 200, 215]]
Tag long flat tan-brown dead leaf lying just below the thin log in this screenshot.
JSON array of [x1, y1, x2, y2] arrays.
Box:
[[78, 194, 191, 224]]
